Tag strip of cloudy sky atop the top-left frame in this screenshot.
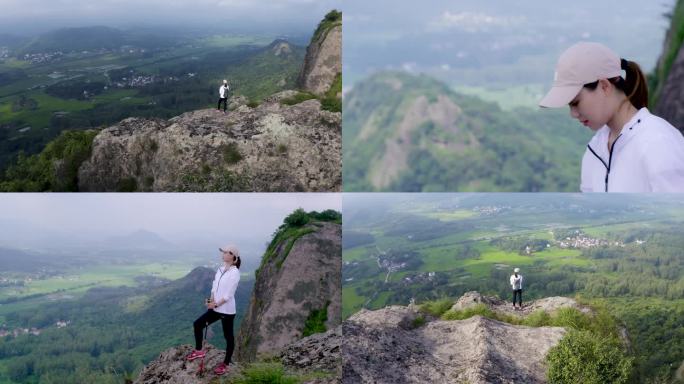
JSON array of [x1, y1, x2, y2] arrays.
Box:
[[0, 0, 341, 34]]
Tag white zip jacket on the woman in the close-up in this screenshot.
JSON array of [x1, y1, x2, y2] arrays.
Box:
[[581, 108, 684, 192]]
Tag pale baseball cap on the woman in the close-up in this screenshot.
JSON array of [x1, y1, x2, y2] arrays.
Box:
[[539, 42, 622, 108]]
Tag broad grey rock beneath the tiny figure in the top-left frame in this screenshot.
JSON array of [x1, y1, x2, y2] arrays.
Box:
[[79, 91, 341, 191]]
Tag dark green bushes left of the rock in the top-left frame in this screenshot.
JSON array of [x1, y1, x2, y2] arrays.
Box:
[[0, 130, 97, 192]]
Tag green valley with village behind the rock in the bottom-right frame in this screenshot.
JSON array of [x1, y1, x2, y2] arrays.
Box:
[[342, 194, 684, 382]]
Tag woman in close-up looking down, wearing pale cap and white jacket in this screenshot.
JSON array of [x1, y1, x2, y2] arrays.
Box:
[[539, 42, 684, 192]]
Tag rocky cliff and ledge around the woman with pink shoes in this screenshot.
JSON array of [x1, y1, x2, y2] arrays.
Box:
[[134, 210, 342, 384]]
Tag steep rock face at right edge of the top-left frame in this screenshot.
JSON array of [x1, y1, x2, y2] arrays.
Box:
[[297, 11, 342, 96]]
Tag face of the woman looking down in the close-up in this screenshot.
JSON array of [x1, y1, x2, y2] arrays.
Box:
[[568, 79, 615, 131]]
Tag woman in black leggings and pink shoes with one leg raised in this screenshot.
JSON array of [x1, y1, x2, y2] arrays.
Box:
[[187, 245, 241, 375]]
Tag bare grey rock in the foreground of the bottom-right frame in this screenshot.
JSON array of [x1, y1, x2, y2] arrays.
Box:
[[342, 292, 588, 384]]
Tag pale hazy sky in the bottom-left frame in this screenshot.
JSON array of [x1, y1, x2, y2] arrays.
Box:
[[0, 193, 341, 248]]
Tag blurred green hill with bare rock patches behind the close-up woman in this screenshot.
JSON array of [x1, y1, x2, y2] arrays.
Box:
[[343, 72, 591, 192]]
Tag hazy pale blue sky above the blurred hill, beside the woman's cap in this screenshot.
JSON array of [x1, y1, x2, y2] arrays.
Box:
[[343, 0, 674, 87]]
